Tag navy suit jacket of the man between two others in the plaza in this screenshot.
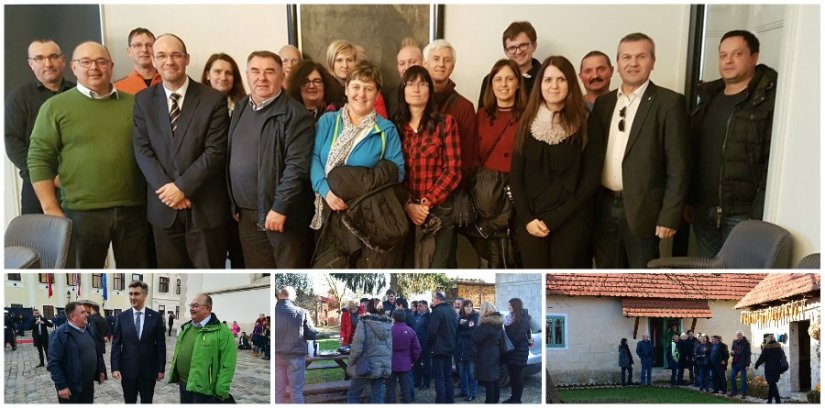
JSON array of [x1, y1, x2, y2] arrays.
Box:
[[112, 307, 166, 380]]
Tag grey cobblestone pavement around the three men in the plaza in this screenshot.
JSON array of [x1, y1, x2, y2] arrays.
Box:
[[3, 333, 271, 404]]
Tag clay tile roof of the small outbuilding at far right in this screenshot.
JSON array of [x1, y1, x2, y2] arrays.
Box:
[[736, 272, 820, 309]]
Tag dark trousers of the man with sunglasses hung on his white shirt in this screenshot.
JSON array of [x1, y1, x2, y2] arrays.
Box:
[[592, 189, 659, 269]]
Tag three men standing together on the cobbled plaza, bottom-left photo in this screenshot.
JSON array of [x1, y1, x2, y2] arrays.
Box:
[[25, 281, 236, 404]]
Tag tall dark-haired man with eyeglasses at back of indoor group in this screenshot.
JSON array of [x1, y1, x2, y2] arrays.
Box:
[[478, 21, 541, 106]]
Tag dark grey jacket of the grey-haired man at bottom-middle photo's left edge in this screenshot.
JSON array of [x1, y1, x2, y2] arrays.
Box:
[[275, 300, 318, 358]]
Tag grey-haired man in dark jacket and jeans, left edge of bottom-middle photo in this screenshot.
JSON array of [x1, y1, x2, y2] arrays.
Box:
[[275, 286, 318, 403]]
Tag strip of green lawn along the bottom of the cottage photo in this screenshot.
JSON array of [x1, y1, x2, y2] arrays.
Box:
[[559, 387, 745, 404]]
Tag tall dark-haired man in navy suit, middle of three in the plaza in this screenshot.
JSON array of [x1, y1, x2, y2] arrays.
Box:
[[112, 281, 166, 404]]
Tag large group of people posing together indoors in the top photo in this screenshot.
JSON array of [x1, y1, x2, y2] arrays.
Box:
[[5, 17, 777, 270]]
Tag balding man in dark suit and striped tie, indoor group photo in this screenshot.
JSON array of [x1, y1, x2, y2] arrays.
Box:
[[134, 34, 229, 268]]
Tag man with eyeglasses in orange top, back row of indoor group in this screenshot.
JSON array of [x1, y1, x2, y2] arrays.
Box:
[[115, 27, 161, 95]]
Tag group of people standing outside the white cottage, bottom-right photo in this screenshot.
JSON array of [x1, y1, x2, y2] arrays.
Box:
[[619, 325, 788, 403]]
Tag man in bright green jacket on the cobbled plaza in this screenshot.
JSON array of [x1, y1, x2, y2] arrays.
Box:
[[169, 294, 238, 404]]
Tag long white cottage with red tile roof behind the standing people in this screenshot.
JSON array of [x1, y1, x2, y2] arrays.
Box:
[[545, 273, 765, 385]]
